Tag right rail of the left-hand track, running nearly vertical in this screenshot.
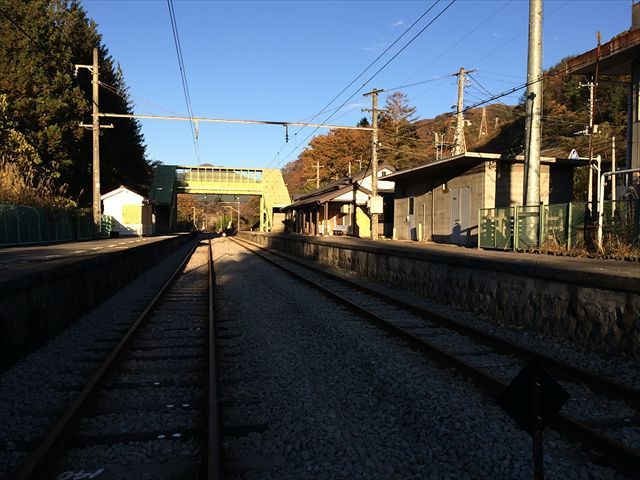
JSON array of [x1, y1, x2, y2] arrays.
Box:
[[209, 239, 222, 480]]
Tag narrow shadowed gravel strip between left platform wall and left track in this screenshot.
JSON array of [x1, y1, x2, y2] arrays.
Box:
[[0, 238, 198, 478]]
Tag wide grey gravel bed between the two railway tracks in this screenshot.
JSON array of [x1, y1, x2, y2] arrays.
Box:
[[214, 239, 624, 479]]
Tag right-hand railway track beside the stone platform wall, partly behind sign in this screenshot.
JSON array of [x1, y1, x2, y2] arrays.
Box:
[[230, 237, 640, 478]]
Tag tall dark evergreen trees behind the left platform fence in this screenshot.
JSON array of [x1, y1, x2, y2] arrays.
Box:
[[0, 0, 150, 210]]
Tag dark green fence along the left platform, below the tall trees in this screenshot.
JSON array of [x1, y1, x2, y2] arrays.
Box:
[[0, 204, 93, 246]]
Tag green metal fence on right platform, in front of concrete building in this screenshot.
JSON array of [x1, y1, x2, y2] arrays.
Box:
[[478, 200, 640, 250]]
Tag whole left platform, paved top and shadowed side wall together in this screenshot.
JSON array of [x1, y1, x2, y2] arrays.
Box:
[[0, 234, 193, 370]]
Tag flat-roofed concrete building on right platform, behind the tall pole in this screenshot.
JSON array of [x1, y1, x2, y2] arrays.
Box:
[[387, 152, 586, 247]]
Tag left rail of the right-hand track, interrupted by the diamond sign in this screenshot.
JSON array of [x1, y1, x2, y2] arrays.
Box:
[[229, 237, 640, 478]]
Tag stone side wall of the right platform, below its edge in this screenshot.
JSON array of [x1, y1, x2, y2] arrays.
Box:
[[240, 232, 640, 355]]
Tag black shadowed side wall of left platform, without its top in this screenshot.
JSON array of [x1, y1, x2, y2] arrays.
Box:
[[0, 235, 193, 371]]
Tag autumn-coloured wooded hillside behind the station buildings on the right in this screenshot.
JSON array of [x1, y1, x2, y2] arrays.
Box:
[[283, 60, 627, 199]]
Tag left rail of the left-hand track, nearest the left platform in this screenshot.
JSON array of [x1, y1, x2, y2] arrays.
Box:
[[16, 239, 200, 480]]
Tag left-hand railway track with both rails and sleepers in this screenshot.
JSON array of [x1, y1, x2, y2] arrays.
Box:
[[16, 237, 220, 480]]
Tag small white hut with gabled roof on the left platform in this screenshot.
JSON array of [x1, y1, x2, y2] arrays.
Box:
[[100, 185, 155, 236]]
